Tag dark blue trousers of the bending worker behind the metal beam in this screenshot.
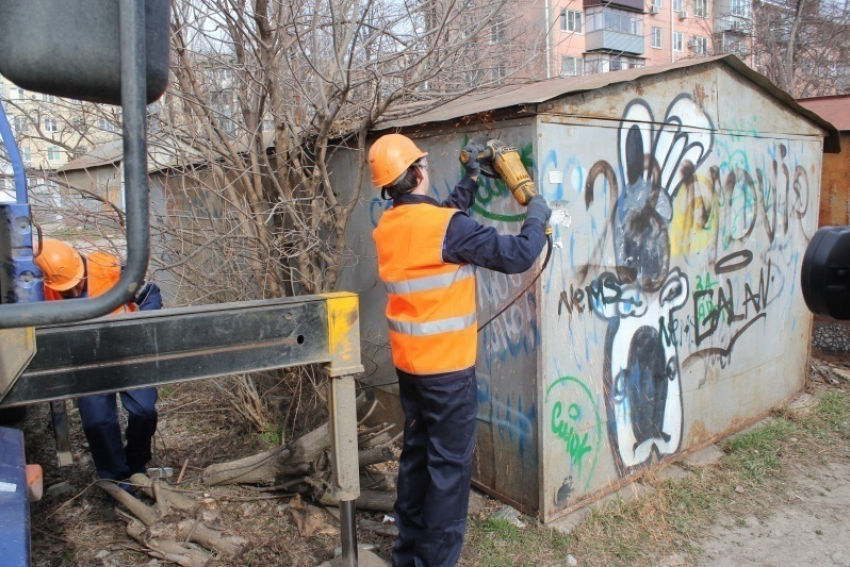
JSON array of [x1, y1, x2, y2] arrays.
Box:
[[77, 387, 157, 480]]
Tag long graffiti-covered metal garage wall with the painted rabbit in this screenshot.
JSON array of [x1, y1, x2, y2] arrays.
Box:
[[538, 66, 822, 520]]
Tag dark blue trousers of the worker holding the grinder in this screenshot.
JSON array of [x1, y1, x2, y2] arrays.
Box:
[[393, 371, 478, 567]]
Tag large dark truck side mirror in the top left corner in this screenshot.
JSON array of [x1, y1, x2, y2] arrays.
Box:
[[0, 0, 171, 105]]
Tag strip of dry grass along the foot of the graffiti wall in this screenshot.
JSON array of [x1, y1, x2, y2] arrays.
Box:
[[463, 382, 850, 567]]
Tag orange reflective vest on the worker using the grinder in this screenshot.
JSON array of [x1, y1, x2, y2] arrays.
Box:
[[373, 203, 478, 374]]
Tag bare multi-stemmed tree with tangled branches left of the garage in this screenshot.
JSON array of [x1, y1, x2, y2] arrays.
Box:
[[154, 0, 506, 306]]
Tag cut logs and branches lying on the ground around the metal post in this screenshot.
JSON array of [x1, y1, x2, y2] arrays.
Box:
[[98, 398, 401, 567]]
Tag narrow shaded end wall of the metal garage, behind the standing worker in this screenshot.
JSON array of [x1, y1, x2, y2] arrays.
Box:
[[332, 123, 541, 513]]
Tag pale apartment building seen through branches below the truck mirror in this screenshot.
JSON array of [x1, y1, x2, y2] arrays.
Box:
[[0, 76, 121, 173]]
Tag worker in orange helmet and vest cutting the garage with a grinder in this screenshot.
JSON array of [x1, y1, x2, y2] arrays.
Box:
[[369, 134, 551, 567]]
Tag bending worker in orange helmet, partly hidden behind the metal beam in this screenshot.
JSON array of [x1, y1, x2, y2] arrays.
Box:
[[35, 238, 162, 488]]
